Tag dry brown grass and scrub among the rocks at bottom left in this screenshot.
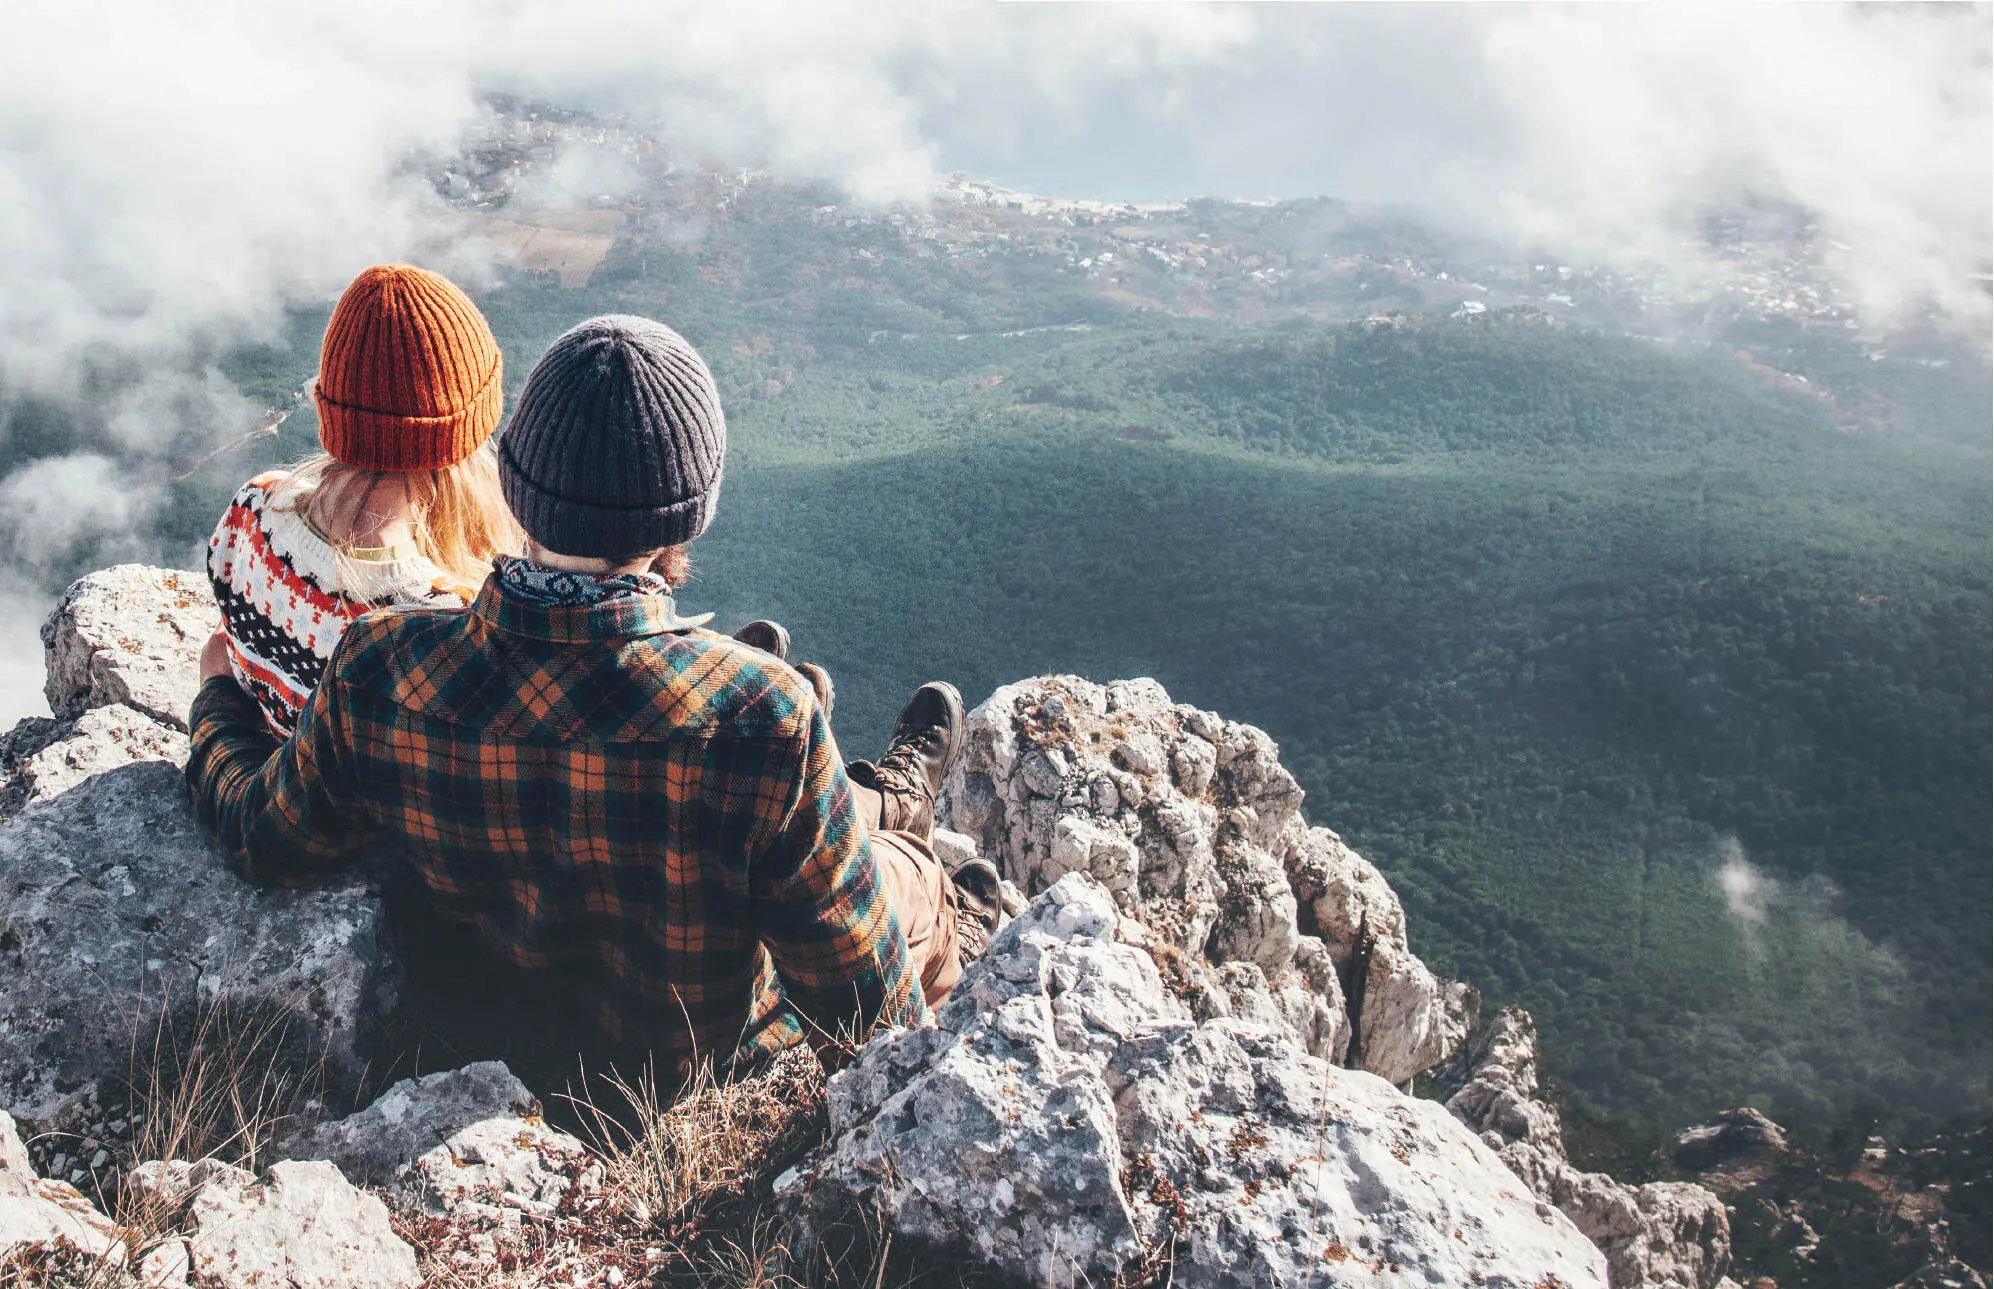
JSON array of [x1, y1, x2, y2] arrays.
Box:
[[0, 1004, 1028, 1289]]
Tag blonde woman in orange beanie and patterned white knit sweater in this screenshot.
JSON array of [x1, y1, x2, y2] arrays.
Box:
[[207, 263, 522, 736]]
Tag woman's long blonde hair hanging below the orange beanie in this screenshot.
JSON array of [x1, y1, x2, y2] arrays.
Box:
[[269, 439, 526, 589]]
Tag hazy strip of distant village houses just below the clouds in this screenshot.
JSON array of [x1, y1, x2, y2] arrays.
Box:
[[423, 96, 1986, 387]]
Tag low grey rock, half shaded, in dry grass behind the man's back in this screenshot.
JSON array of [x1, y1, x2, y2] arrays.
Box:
[[277, 1062, 602, 1217]]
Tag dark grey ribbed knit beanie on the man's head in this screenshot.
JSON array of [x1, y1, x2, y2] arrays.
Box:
[[499, 313, 728, 559]]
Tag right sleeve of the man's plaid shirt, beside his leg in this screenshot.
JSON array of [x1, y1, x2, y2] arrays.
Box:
[[750, 708, 927, 1054]]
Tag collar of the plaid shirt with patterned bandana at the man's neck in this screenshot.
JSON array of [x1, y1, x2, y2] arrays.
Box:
[[471, 555, 714, 645]]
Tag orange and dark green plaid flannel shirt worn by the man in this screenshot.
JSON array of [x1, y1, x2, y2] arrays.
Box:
[[187, 573, 927, 1070]]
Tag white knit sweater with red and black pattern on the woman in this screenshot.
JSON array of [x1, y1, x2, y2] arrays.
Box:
[[207, 471, 477, 738]]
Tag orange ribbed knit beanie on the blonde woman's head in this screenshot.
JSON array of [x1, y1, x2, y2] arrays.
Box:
[[317, 263, 504, 471]]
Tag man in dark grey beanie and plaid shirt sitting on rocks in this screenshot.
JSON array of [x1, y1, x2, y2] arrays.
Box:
[[187, 317, 999, 1074]]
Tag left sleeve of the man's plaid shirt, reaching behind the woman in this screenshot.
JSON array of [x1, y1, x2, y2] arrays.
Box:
[[187, 633, 375, 886]]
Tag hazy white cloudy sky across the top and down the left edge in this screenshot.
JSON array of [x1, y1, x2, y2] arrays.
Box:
[[0, 0, 1994, 718]]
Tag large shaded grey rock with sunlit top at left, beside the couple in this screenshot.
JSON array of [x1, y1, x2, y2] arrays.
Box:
[[0, 565, 399, 1131]]
